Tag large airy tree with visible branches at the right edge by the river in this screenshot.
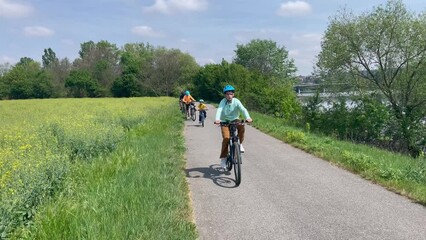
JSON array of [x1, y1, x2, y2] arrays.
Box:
[[317, 0, 426, 155]]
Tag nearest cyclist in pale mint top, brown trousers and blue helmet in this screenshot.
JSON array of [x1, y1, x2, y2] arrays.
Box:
[[215, 85, 253, 169]]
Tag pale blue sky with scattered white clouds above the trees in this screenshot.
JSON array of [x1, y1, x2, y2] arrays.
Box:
[[0, 0, 426, 75]]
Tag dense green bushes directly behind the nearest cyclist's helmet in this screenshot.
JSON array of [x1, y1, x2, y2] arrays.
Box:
[[194, 61, 301, 121]]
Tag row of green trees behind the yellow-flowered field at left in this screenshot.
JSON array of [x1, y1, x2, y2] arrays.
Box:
[[0, 41, 199, 99]]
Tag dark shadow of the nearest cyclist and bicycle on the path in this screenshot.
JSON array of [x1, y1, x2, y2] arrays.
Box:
[[185, 164, 238, 188]]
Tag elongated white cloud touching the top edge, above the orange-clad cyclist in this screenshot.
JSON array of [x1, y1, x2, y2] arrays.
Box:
[[145, 0, 207, 14]]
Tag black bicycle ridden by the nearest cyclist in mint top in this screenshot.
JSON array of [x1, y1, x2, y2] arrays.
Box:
[[220, 120, 245, 186]]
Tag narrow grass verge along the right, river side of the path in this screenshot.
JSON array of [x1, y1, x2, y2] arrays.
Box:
[[250, 112, 426, 205]]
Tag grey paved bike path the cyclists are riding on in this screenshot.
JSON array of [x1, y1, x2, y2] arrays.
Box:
[[185, 105, 426, 240]]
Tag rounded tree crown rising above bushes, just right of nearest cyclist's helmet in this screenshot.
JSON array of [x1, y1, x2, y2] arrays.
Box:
[[234, 39, 297, 79]]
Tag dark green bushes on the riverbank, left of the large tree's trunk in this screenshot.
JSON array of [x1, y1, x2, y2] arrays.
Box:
[[300, 96, 390, 146]]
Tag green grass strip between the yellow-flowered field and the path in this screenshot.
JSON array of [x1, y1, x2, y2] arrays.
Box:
[[19, 101, 197, 239]]
